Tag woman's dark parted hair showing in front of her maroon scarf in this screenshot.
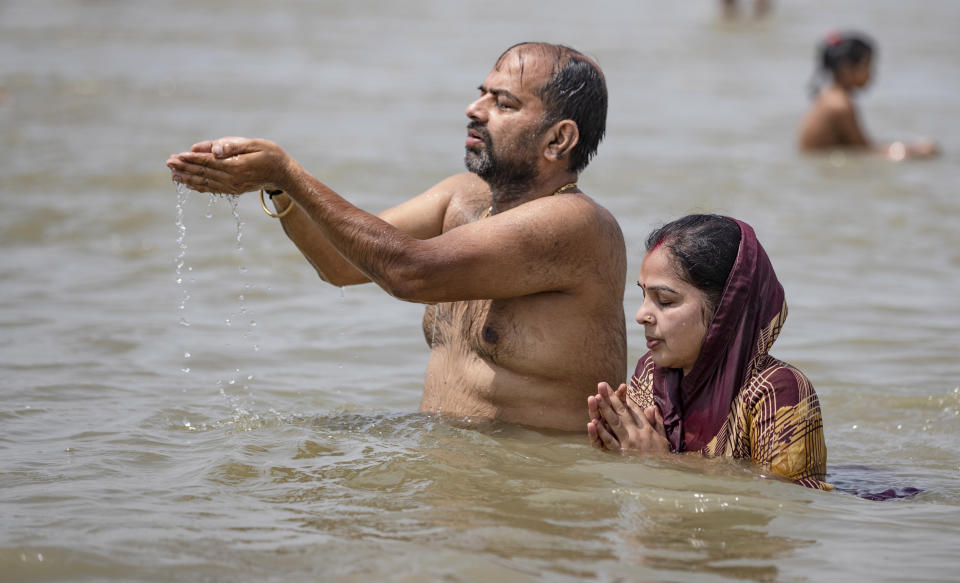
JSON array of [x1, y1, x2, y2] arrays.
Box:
[[647, 215, 740, 322]]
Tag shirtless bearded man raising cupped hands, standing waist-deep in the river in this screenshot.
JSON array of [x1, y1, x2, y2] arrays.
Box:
[[167, 43, 626, 431]]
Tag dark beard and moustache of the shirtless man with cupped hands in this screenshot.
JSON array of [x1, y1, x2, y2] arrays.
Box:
[[463, 121, 540, 201]]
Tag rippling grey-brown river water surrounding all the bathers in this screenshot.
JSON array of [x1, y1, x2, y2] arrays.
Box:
[[0, 0, 960, 582]]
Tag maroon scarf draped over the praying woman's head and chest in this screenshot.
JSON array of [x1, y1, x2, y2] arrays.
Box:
[[653, 219, 787, 452]]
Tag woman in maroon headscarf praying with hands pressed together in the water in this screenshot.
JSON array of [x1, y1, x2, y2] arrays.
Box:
[[587, 215, 832, 490]]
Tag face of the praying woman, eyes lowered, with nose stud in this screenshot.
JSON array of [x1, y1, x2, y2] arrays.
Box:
[[637, 246, 712, 375]]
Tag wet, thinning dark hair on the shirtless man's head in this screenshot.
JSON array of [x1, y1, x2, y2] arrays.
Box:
[[497, 42, 607, 174]]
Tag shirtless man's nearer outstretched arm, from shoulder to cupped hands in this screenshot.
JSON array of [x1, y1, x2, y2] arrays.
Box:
[[168, 140, 598, 303]]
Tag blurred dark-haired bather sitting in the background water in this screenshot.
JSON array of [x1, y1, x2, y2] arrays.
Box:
[[800, 33, 937, 160]]
